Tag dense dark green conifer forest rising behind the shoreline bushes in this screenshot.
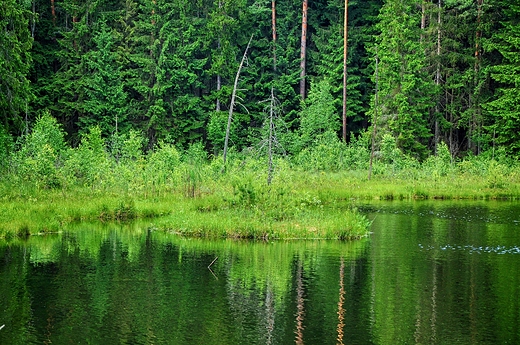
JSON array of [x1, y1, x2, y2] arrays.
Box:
[[0, 0, 520, 165]]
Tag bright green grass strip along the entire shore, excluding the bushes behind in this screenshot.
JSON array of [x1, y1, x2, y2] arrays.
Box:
[[0, 155, 520, 239]]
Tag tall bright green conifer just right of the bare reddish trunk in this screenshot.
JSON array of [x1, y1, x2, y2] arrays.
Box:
[[378, 0, 434, 158]]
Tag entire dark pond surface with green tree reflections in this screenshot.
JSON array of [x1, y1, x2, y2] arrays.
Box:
[[0, 201, 520, 344]]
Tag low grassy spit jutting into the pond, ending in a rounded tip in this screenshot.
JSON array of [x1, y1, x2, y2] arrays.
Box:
[[0, 181, 369, 239]]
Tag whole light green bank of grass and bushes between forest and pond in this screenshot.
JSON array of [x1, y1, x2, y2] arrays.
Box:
[[0, 123, 520, 239]]
